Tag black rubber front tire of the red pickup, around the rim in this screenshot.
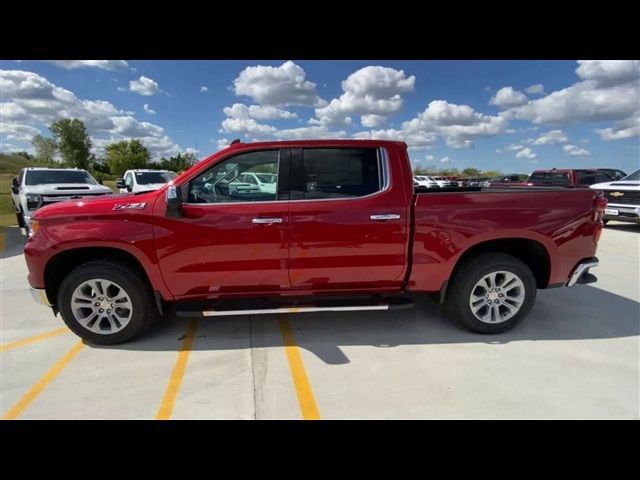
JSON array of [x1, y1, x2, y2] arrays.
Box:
[[57, 259, 159, 345]]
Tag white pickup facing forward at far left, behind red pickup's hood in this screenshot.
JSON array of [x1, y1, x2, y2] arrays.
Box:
[[11, 167, 113, 228]]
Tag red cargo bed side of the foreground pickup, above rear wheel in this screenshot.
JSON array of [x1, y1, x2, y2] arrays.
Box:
[[407, 187, 599, 292]]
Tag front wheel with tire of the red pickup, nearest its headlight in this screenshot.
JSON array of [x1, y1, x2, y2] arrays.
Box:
[[58, 259, 158, 345]]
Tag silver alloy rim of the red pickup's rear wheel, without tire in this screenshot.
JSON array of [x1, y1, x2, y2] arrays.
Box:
[[469, 271, 525, 324]]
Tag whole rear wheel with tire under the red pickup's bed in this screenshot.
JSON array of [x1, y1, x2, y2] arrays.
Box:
[[446, 252, 536, 333]]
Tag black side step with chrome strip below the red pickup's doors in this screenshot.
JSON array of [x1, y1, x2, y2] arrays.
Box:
[[176, 297, 413, 318]]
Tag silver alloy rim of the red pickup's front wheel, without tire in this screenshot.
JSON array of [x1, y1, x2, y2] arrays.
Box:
[[71, 278, 133, 335]]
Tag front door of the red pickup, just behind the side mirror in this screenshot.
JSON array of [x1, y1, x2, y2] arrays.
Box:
[[155, 149, 290, 297]]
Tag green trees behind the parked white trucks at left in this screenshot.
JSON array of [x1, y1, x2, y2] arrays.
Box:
[[29, 118, 198, 179]]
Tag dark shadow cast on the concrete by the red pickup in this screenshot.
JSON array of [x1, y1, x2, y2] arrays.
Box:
[[94, 286, 640, 365]]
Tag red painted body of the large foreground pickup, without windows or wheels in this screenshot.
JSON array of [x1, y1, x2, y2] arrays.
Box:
[[25, 140, 602, 300]]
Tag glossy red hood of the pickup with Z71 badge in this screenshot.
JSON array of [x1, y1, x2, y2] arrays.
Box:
[[32, 190, 159, 221]]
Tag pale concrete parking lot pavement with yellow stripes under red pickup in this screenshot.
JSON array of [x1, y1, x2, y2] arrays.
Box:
[[0, 222, 640, 419]]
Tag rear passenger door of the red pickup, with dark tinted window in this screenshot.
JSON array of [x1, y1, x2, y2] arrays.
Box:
[[289, 147, 411, 291]]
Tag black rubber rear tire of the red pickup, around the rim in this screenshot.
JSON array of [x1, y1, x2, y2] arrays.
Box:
[[445, 252, 537, 334]]
